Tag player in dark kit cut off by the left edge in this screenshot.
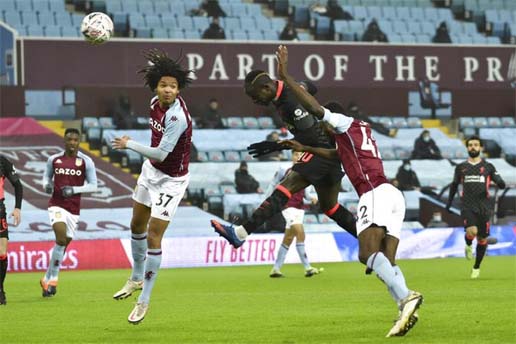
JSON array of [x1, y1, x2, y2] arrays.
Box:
[[0, 155, 23, 305]]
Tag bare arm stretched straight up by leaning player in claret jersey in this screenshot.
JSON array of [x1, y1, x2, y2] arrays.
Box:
[[276, 45, 324, 119]]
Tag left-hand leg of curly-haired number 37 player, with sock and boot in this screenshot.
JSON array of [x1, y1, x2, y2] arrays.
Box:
[[113, 202, 151, 300]]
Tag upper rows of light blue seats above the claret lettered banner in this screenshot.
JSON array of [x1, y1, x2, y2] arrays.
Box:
[[0, 0, 516, 44]]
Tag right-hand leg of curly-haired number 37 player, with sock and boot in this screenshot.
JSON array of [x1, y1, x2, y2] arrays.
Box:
[[127, 217, 169, 325]]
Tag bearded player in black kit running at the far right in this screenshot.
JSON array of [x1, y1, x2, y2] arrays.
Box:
[[446, 136, 505, 278]]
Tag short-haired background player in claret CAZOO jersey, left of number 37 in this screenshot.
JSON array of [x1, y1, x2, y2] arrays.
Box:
[[40, 128, 97, 297]]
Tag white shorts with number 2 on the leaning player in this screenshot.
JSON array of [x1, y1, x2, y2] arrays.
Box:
[[357, 183, 405, 239]]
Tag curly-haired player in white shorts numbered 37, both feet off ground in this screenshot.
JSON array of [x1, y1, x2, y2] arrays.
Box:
[[112, 50, 192, 324]]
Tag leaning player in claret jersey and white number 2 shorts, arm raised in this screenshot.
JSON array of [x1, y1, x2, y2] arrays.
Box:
[[276, 46, 423, 337]]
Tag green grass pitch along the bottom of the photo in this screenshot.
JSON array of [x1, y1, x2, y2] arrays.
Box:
[[0, 256, 516, 344]]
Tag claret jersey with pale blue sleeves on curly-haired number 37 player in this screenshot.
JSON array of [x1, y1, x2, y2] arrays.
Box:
[[149, 96, 192, 177]]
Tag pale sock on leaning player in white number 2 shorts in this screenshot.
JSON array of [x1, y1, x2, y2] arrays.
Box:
[[367, 252, 409, 300]]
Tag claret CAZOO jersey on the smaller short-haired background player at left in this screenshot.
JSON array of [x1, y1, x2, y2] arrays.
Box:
[[45, 152, 95, 215]]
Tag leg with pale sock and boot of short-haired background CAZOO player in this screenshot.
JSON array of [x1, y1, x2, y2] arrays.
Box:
[[39, 222, 67, 297]]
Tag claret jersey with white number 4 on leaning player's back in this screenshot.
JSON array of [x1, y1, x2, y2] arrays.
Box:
[[324, 109, 389, 196]]
